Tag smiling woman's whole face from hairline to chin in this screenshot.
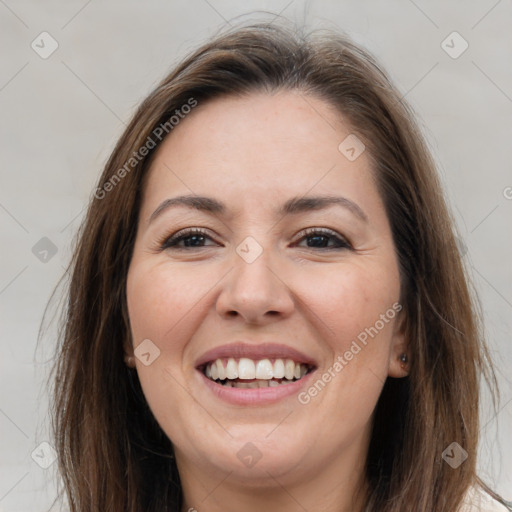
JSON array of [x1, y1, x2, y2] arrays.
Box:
[[127, 91, 405, 488]]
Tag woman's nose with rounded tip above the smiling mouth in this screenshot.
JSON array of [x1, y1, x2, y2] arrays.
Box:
[[216, 250, 295, 325]]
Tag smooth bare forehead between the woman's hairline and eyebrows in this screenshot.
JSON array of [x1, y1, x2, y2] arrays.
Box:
[[140, 91, 376, 219]]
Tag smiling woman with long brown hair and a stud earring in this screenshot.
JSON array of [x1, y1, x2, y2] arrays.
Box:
[[54, 25, 506, 512]]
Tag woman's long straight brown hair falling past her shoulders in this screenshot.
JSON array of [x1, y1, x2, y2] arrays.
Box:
[[53, 24, 506, 512]]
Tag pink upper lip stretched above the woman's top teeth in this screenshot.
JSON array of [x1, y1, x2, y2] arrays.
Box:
[[196, 341, 316, 368]]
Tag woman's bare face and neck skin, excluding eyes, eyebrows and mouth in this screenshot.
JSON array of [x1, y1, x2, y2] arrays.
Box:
[[126, 91, 406, 512]]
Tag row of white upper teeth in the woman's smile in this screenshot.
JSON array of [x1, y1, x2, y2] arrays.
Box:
[[205, 357, 308, 380]]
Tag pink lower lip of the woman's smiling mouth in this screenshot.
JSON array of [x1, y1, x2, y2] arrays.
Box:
[[198, 370, 315, 405]]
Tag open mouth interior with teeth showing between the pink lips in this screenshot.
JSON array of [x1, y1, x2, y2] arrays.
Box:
[[198, 357, 315, 389]]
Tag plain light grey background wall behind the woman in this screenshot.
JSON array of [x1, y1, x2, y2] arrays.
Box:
[[0, 0, 512, 512]]
